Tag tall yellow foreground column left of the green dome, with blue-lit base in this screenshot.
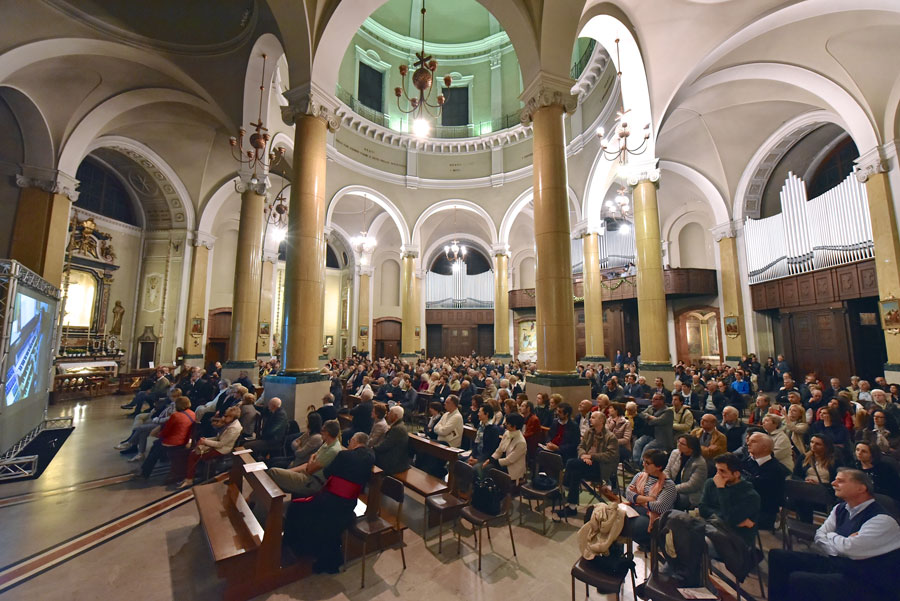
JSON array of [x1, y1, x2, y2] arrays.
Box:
[[266, 83, 339, 423]]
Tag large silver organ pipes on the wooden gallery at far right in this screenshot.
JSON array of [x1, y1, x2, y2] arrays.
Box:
[[744, 173, 874, 284]]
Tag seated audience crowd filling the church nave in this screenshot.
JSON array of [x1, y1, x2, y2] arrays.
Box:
[[117, 352, 900, 601]]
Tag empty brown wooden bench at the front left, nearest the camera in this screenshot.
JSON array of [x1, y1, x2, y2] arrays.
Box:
[[193, 448, 312, 601]]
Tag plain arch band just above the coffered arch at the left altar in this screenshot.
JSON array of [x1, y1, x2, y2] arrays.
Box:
[[59, 88, 234, 173]]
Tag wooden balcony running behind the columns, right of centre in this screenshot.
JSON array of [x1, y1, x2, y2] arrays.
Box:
[[509, 269, 717, 309]]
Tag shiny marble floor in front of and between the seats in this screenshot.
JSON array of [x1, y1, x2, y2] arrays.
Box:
[[0, 396, 776, 601]]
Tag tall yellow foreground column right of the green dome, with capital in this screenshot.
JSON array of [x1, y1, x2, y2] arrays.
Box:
[[520, 74, 590, 403]]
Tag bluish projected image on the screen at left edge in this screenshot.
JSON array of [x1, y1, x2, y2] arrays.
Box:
[[6, 292, 53, 406]]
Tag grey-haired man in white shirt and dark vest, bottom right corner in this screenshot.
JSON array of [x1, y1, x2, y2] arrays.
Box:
[[769, 469, 900, 601]]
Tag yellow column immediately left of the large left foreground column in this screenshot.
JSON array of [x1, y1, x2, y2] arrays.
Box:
[[222, 176, 266, 382]]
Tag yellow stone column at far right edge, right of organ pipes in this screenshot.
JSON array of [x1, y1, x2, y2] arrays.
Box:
[[856, 148, 900, 382]]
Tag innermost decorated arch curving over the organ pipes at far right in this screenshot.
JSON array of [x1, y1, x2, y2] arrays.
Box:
[[731, 110, 859, 221]]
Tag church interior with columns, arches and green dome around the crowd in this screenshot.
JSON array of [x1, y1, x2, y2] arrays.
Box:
[[0, 0, 900, 601]]
